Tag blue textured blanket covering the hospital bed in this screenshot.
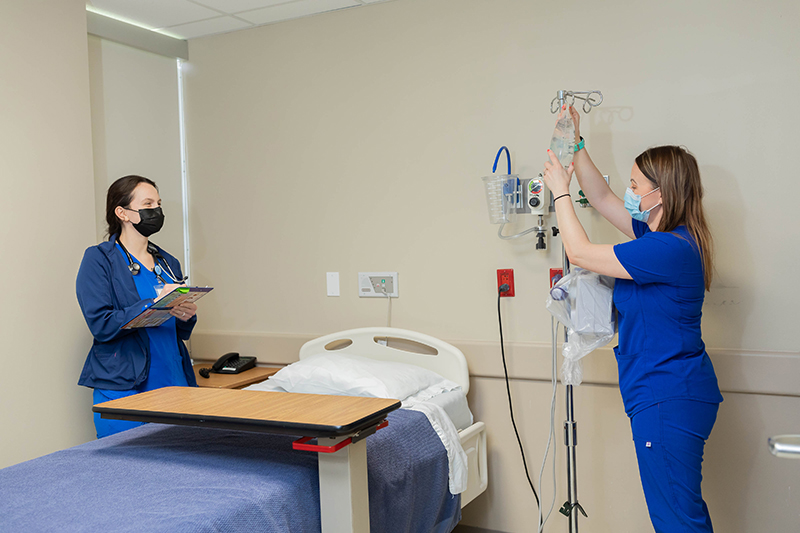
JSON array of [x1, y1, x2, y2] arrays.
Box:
[[0, 410, 461, 533]]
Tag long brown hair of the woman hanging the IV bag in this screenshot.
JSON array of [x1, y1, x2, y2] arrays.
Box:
[[636, 146, 714, 290]]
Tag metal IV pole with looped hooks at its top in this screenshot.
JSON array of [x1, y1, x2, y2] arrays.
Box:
[[550, 91, 603, 533]]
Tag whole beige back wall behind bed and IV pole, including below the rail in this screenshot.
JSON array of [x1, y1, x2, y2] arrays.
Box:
[[185, 0, 800, 531]]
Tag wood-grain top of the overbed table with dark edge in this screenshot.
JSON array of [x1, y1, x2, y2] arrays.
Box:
[[92, 387, 400, 437]]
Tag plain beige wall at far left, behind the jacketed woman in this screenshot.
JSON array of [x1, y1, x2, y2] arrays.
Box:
[[0, 0, 94, 467]]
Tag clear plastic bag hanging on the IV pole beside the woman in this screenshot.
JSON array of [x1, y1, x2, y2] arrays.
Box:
[[547, 268, 617, 385]]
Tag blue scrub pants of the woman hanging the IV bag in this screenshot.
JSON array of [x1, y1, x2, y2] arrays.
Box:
[[631, 400, 719, 533]]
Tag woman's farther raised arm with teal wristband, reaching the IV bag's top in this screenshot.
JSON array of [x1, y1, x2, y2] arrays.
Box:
[[569, 107, 635, 239]]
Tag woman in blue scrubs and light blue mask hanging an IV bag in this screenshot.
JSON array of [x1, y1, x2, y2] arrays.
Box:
[[544, 109, 722, 533]]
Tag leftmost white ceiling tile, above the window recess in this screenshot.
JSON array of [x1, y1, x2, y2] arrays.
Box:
[[86, 0, 219, 29]]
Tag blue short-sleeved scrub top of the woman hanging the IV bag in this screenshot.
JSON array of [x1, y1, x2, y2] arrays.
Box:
[[614, 220, 722, 417]]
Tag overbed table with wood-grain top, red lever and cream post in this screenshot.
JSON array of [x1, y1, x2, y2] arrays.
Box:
[[92, 387, 400, 533]]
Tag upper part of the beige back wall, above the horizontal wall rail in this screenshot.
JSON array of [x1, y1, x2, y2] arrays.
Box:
[[187, 0, 800, 351]]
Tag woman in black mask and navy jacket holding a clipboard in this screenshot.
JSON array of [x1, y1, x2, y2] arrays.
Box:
[[76, 176, 197, 438]]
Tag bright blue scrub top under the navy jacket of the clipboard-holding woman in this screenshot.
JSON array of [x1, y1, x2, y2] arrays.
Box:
[[117, 243, 189, 392]]
